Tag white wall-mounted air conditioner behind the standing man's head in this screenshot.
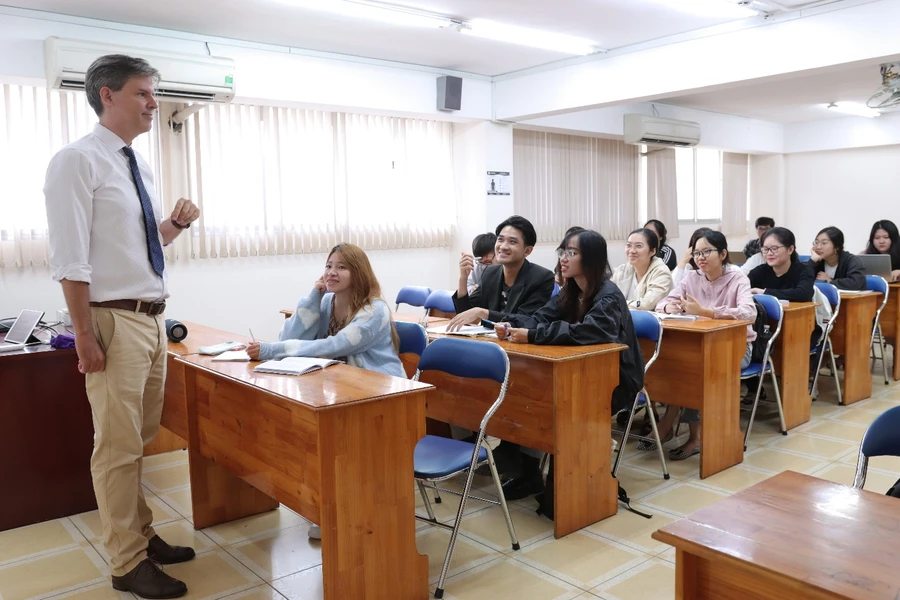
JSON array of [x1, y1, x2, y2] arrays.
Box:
[[44, 37, 234, 102]]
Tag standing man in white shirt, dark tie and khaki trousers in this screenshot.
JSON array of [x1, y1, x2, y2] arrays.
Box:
[[44, 54, 200, 598]]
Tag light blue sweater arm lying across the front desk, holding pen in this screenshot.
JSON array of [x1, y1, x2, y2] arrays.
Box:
[[259, 304, 391, 360]]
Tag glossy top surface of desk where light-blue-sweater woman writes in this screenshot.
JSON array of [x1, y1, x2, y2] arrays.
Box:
[[176, 354, 433, 410]]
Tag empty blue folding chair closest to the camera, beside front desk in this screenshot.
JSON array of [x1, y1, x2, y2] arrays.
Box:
[[413, 338, 519, 598]]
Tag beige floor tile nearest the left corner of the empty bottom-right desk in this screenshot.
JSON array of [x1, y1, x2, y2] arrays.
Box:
[[512, 531, 651, 589]]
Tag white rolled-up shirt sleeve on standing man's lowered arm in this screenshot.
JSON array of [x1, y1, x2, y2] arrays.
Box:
[[44, 150, 94, 283]]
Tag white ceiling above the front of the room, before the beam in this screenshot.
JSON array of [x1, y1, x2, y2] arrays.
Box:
[[0, 0, 788, 76]]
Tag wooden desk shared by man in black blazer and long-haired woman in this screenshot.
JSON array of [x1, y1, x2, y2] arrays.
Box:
[[421, 335, 625, 538]]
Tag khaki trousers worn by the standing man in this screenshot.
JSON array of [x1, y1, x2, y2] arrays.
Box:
[[85, 308, 166, 577]]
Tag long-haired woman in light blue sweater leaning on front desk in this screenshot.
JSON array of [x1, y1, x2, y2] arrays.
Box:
[[247, 243, 406, 377]]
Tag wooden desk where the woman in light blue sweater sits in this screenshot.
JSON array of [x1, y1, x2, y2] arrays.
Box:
[[177, 355, 432, 600]]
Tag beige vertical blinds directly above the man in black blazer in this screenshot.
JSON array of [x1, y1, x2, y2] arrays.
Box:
[[513, 129, 640, 242]]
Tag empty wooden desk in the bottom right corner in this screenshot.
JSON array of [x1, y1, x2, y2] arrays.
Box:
[[653, 471, 900, 600]]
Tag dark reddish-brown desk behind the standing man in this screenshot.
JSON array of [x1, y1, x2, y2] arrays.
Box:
[[0, 334, 97, 531]]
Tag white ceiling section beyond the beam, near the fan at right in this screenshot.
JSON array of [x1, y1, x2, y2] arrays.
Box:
[[659, 58, 896, 124]]
